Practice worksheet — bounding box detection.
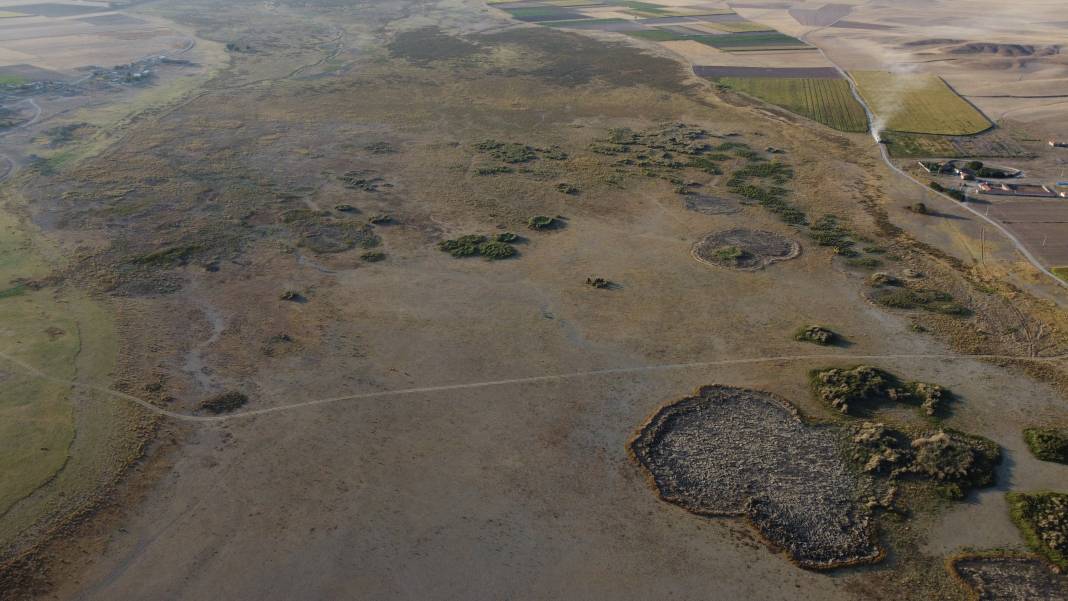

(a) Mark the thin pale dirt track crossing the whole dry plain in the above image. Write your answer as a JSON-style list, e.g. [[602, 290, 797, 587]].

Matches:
[[0, 353, 1068, 423]]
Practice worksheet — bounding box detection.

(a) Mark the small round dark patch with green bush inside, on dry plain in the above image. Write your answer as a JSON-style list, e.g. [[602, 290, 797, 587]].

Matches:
[[691, 228, 801, 271]]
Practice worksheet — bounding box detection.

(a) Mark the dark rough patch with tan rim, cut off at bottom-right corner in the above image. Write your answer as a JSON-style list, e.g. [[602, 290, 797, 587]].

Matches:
[[949, 555, 1068, 601]]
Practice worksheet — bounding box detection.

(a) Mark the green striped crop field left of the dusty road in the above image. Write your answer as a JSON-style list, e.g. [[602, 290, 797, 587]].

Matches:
[[717, 77, 867, 131]]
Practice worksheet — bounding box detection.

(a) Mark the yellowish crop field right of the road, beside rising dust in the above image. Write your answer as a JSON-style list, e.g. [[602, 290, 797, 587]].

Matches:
[[850, 70, 992, 136]]
